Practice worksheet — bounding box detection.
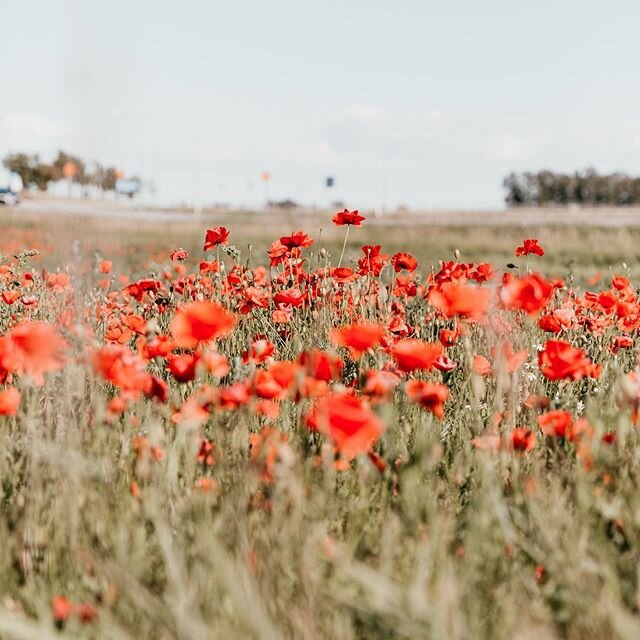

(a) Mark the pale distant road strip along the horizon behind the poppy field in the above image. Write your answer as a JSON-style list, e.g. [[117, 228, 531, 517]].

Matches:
[[6, 199, 640, 227]]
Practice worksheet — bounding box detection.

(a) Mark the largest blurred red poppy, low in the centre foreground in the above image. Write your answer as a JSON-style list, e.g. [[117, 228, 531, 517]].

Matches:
[[307, 393, 383, 460]]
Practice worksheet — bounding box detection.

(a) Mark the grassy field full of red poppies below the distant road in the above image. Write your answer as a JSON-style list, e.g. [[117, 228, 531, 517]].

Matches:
[[0, 210, 640, 640]]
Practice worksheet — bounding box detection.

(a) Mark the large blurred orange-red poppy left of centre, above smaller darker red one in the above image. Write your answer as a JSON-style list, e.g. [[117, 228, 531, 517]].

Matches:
[[171, 301, 235, 348]]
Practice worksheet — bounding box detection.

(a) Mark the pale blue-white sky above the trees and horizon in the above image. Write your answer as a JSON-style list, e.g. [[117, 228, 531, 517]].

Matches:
[[0, 0, 640, 209]]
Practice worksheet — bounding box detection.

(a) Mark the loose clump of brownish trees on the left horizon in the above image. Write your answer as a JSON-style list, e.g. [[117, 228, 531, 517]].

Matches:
[[2, 151, 131, 193]]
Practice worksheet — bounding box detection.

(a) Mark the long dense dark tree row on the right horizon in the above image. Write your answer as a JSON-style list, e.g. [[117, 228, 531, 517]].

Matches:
[[503, 169, 640, 207]]
